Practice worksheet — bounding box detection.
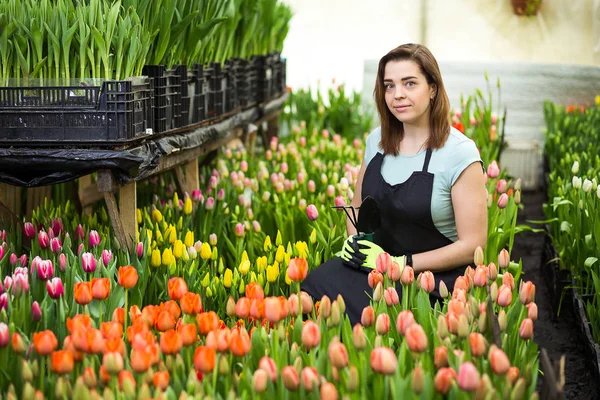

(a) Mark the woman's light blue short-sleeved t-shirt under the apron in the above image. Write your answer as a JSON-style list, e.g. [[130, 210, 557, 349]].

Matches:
[[364, 127, 483, 242]]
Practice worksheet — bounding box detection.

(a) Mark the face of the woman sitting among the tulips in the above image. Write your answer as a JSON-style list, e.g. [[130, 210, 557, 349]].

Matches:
[[383, 60, 435, 126]]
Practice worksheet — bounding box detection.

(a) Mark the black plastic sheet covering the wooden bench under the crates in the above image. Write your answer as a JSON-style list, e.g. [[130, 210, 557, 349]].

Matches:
[[0, 99, 278, 187]]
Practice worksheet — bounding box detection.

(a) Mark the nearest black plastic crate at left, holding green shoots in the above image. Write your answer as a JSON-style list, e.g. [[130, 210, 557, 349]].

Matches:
[[0, 78, 153, 144]]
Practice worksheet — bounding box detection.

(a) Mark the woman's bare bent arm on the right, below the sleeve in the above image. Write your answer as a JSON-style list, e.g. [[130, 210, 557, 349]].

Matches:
[[412, 163, 488, 272]]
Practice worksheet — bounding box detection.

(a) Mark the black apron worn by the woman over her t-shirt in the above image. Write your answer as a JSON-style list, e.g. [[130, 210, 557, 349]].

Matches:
[[301, 149, 466, 325]]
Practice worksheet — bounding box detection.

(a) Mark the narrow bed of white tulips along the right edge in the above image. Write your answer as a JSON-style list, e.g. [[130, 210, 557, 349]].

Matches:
[[544, 98, 600, 376]]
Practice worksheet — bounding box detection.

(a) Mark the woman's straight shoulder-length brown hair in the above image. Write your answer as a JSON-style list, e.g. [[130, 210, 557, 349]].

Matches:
[[373, 43, 450, 156]]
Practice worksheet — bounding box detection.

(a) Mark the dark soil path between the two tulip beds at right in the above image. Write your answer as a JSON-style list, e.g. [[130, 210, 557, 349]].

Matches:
[[511, 191, 600, 400]]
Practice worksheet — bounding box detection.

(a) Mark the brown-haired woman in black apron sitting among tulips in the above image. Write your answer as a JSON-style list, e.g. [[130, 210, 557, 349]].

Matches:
[[302, 44, 487, 325]]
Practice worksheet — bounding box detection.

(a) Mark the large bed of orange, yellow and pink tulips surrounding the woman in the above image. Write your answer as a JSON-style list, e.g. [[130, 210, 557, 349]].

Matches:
[[0, 91, 538, 399]]
